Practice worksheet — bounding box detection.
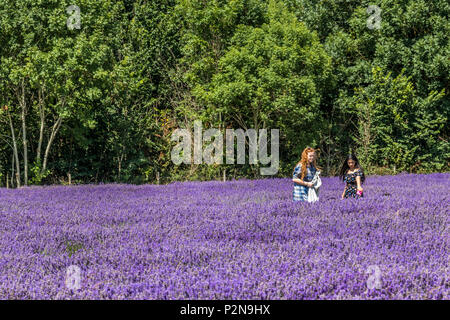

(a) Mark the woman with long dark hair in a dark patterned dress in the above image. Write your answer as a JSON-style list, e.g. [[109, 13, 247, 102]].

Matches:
[[340, 154, 365, 199]]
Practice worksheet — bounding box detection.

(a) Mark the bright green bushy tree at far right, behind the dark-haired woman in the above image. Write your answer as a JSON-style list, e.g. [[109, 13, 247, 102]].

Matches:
[[349, 68, 450, 172]]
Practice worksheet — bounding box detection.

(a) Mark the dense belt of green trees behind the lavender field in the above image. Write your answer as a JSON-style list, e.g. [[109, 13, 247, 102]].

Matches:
[[0, 0, 450, 186]]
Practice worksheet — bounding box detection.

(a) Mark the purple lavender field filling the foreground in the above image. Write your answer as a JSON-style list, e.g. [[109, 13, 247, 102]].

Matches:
[[0, 173, 450, 299]]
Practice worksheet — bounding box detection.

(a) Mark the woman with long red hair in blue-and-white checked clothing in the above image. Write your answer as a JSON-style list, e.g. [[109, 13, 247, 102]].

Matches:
[[292, 147, 320, 201]]
